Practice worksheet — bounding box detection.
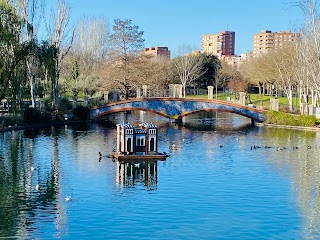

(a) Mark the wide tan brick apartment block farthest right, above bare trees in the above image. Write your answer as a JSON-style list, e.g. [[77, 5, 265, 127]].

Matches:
[[253, 30, 300, 57]]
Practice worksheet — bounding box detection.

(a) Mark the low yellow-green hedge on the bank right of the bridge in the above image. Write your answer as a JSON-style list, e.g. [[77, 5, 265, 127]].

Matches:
[[265, 111, 317, 127]]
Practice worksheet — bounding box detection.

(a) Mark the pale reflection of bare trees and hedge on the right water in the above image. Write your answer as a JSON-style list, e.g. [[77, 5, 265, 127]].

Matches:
[[260, 128, 320, 239]]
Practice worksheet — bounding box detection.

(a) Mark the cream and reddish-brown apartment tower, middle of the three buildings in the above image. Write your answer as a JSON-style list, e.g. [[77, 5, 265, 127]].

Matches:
[[201, 31, 235, 57]]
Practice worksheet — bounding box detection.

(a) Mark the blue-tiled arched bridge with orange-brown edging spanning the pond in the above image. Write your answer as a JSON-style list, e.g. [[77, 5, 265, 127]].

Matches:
[[90, 98, 265, 122]]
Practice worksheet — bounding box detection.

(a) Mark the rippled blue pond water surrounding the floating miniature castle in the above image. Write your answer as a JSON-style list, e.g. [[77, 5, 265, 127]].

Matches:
[[0, 113, 320, 239]]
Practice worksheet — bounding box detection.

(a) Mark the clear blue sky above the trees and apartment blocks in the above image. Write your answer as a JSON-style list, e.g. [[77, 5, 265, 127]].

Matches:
[[69, 0, 303, 56]]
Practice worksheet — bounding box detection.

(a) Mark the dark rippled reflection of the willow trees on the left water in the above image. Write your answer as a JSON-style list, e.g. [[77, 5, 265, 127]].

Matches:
[[0, 128, 63, 238]]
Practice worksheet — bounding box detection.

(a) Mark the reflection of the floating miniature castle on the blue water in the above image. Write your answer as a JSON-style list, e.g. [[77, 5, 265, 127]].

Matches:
[[117, 160, 158, 190]]
